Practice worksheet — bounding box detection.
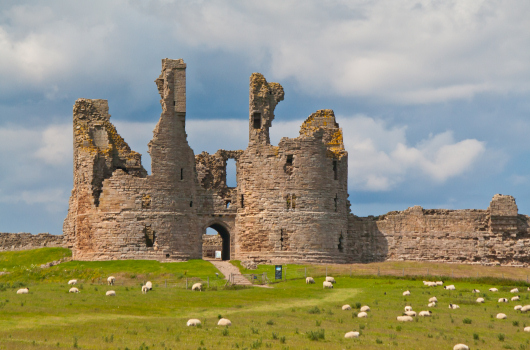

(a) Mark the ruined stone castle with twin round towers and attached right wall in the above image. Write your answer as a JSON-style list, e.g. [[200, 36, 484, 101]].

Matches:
[[63, 59, 530, 265]]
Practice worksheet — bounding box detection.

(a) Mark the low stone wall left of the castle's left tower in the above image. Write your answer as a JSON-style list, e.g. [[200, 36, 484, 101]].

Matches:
[[0, 232, 64, 251]]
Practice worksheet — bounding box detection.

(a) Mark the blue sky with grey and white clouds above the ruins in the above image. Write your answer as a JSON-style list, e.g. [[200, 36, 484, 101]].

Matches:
[[0, 0, 530, 234]]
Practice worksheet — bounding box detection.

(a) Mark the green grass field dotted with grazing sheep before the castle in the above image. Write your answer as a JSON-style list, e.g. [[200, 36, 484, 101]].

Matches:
[[0, 247, 530, 350]]
